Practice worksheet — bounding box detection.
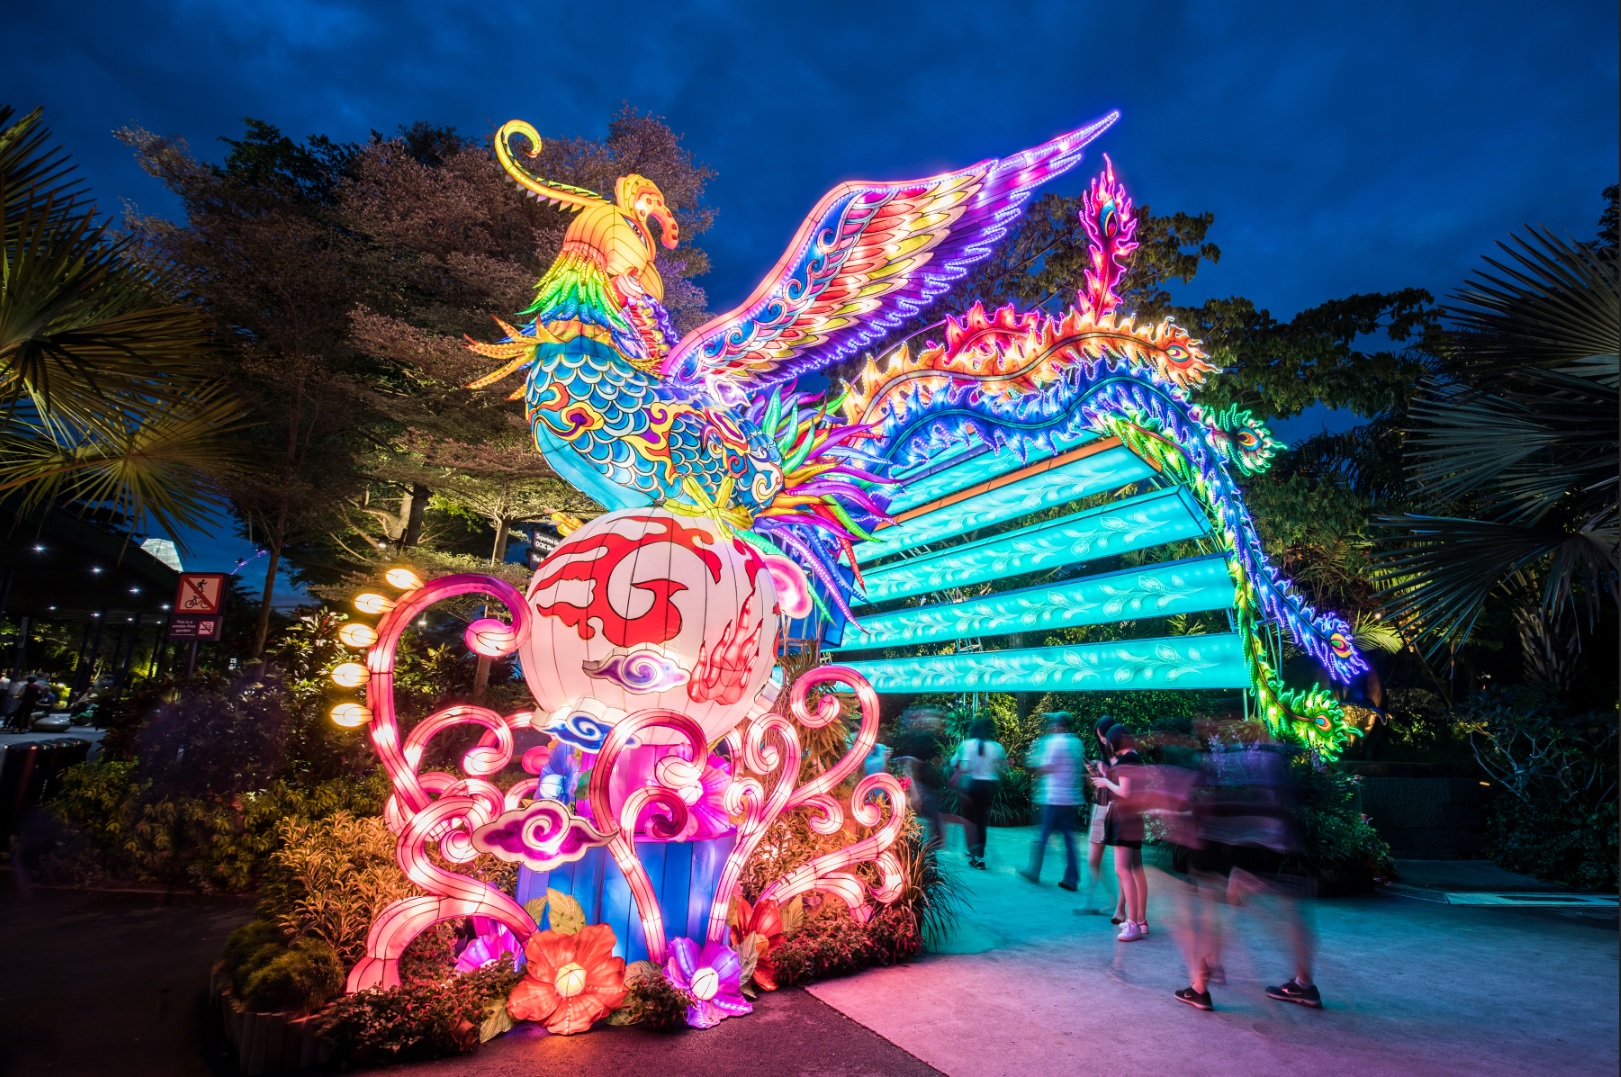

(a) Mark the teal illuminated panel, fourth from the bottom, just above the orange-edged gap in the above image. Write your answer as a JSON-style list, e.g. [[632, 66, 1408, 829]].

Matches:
[[856, 446, 1154, 564]]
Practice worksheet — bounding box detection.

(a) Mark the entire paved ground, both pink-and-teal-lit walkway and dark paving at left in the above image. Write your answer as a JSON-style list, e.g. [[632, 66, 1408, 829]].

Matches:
[[0, 830, 1618, 1077]]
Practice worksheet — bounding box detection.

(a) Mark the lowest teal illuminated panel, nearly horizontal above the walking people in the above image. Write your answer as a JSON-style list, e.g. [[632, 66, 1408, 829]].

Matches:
[[845, 633, 1250, 693]]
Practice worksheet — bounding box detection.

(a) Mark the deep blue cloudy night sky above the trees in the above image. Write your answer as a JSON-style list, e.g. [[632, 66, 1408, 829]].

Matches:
[[0, 0, 1621, 583]]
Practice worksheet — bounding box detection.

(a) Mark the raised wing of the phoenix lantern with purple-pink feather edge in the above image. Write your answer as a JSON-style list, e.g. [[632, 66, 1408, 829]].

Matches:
[[661, 112, 1120, 388]]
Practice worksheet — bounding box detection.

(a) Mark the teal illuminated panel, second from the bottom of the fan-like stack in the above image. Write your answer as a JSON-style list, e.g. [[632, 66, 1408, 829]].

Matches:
[[830, 553, 1234, 650]]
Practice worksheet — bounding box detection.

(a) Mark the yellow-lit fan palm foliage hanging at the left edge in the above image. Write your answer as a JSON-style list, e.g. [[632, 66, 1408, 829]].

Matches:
[[0, 107, 242, 548]]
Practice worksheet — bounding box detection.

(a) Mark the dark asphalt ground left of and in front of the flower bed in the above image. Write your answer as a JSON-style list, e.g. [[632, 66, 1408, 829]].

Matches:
[[0, 873, 935, 1077]]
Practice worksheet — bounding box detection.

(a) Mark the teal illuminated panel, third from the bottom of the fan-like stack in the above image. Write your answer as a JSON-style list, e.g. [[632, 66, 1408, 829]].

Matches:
[[862, 488, 1208, 605]]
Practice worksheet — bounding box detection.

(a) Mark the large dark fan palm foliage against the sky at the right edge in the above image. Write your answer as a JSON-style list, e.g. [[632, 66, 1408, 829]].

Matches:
[[1375, 220, 1621, 654]]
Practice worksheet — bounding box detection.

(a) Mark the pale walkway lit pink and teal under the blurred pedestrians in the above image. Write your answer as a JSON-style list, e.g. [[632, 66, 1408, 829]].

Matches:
[[811, 830, 1618, 1077]]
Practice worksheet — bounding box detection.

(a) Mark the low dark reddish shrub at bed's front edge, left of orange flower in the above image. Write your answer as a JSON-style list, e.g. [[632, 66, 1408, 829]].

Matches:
[[321, 957, 522, 1062]]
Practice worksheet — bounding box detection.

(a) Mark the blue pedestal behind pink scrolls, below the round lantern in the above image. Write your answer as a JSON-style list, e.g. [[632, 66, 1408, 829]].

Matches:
[[517, 834, 738, 962]]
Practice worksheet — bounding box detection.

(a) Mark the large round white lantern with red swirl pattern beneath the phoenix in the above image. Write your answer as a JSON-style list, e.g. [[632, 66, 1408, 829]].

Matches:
[[524, 508, 780, 741]]
